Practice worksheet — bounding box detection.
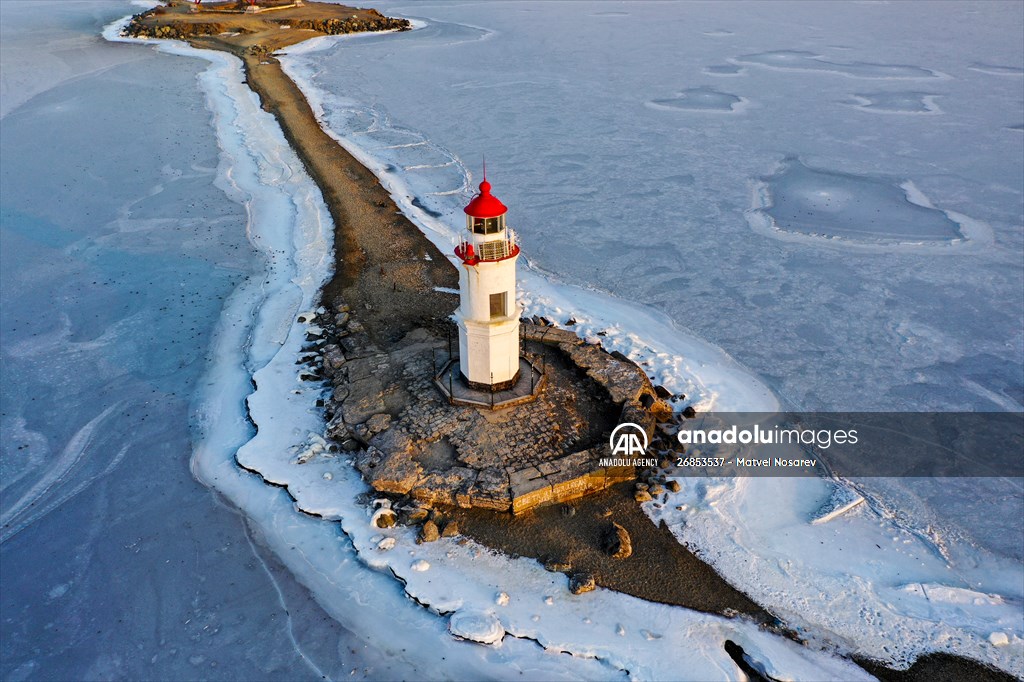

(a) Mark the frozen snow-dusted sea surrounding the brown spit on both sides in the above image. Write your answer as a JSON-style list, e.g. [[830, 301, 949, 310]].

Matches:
[[0, 2, 1024, 679]]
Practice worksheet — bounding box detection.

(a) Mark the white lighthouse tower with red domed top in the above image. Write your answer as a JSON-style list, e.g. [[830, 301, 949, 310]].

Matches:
[[455, 171, 522, 392]]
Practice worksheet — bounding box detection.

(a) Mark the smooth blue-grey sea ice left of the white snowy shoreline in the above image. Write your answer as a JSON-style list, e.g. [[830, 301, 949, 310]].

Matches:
[[0, 0, 411, 682]]
